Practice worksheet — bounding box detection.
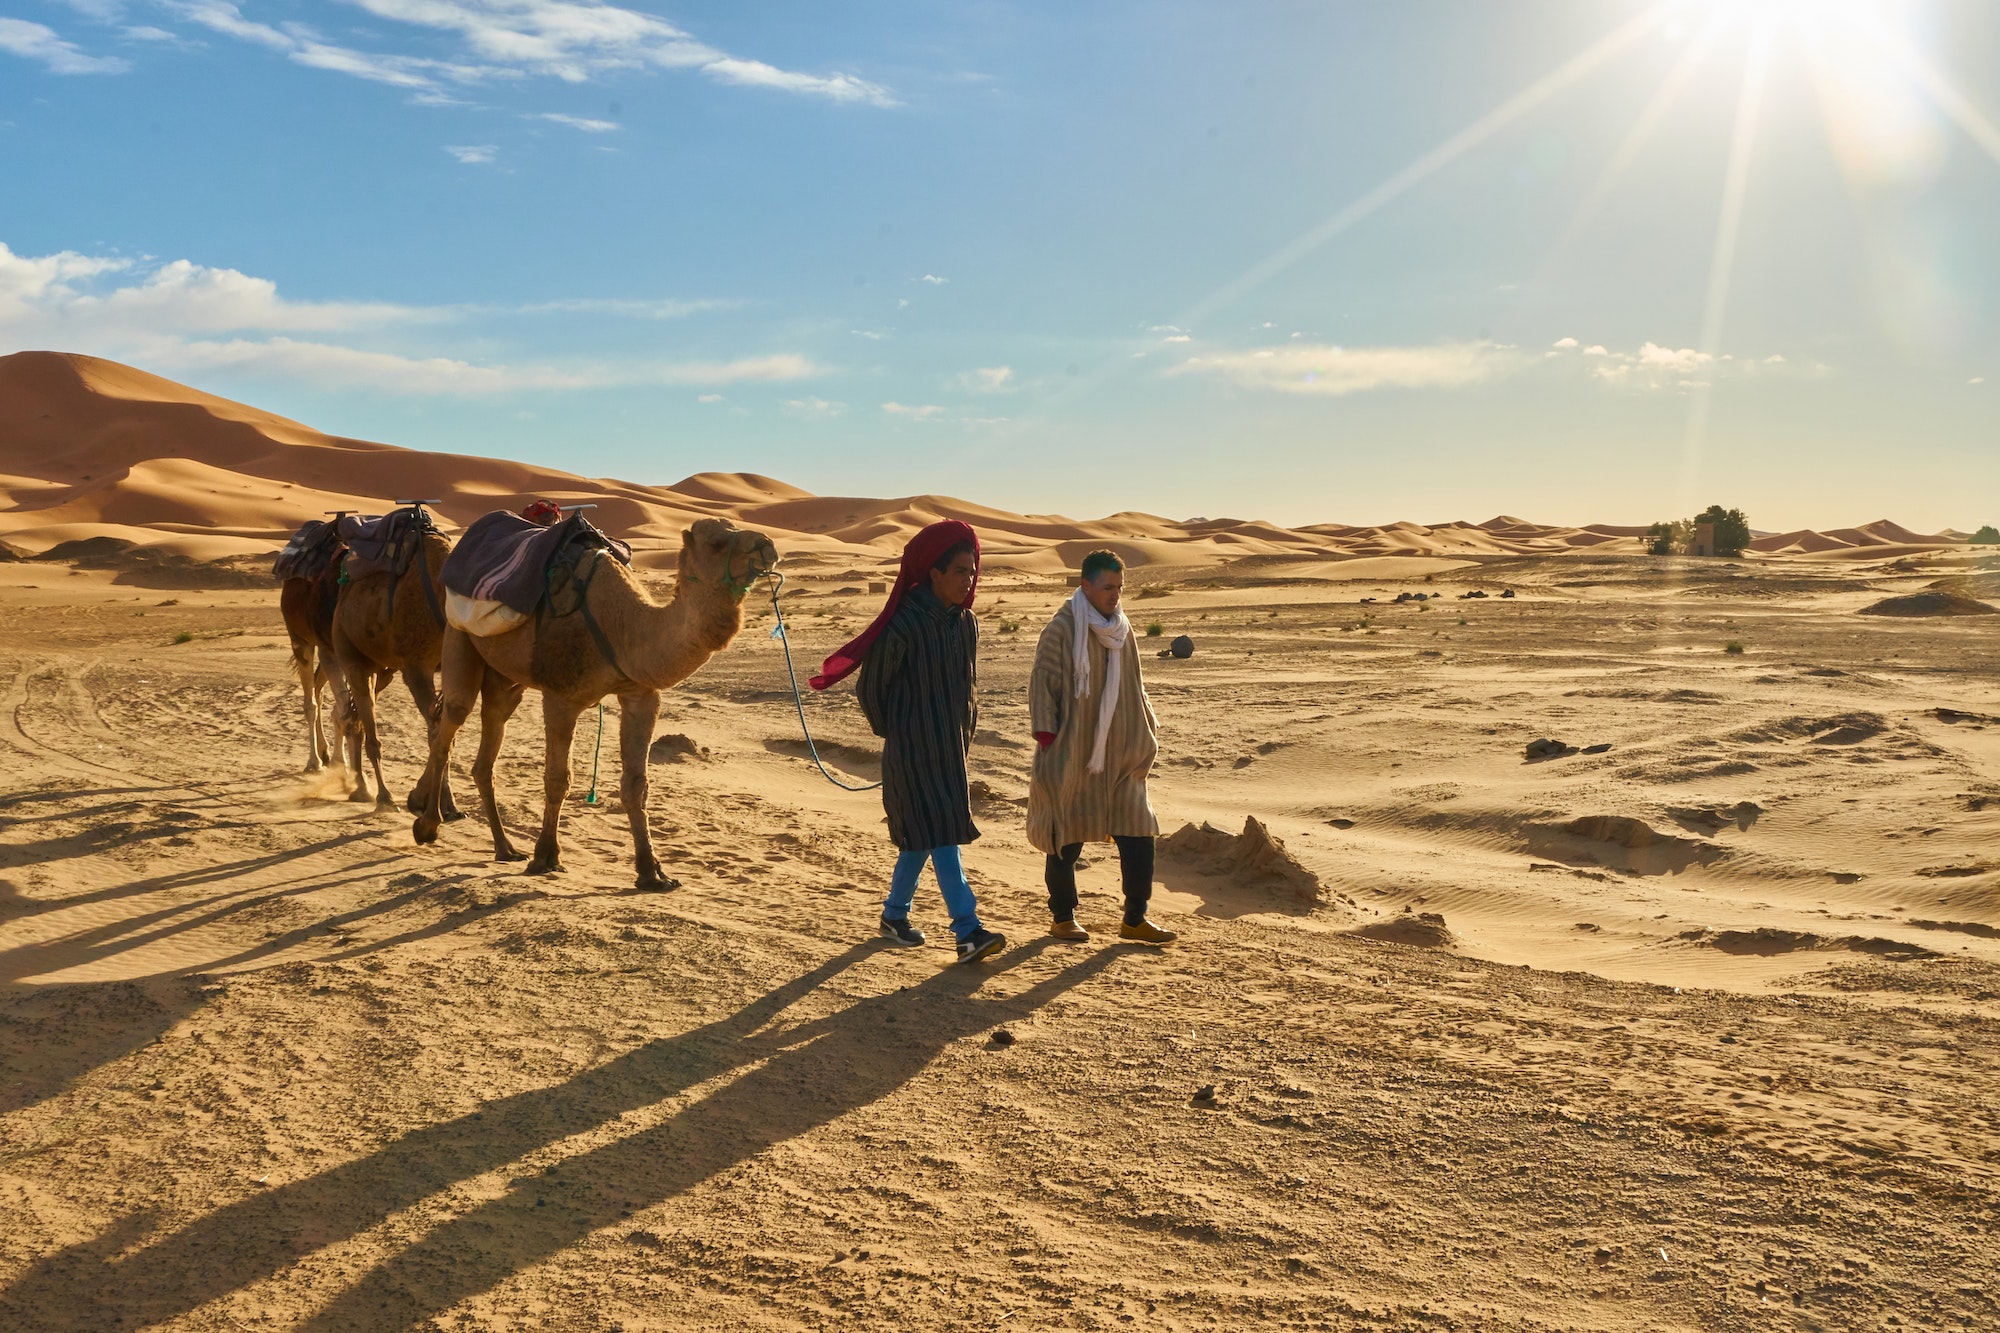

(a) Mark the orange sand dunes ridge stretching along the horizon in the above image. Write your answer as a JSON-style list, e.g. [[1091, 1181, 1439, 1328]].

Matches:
[[0, 352, 1964, 572]]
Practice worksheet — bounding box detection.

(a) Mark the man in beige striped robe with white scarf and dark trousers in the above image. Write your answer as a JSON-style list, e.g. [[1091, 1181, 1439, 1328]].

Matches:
[[1028, 550, 1174, 945]]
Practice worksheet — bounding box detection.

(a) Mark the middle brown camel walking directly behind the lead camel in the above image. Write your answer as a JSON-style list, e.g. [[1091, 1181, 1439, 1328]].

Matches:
[[332, 504, 460, 819]]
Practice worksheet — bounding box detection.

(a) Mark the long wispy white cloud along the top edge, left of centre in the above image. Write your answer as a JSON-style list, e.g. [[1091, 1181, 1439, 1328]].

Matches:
[[162, 0, 896, 106]]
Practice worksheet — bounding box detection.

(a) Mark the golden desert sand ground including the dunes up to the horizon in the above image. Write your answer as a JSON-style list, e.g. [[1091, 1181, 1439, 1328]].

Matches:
[[0, 352, 2000, 1331]]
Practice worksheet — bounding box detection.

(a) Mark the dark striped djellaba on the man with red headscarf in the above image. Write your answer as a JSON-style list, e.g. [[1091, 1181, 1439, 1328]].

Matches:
[[854, 584, 980, 851]]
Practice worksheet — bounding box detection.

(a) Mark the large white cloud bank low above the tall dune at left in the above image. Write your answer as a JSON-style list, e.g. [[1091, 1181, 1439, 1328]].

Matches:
[[0, 244, 824, 394]]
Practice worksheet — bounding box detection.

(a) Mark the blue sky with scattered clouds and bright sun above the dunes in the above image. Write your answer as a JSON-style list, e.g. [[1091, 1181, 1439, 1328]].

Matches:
[[0, 0, 2000, 528]]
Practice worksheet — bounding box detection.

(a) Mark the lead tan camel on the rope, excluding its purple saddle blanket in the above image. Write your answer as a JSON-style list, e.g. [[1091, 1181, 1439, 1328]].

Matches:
[[412, 518, 778, 889]]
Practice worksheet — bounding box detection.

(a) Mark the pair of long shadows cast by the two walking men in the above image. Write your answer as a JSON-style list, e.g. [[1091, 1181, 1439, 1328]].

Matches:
[[0, 932, 1122, 1329]]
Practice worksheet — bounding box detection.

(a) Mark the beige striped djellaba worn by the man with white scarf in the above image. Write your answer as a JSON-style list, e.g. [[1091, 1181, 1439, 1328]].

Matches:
[[1028, 602, 1160, 855]]
